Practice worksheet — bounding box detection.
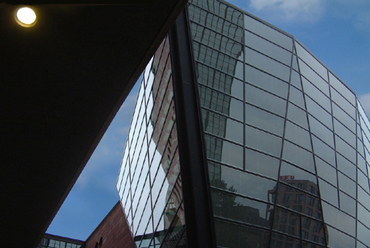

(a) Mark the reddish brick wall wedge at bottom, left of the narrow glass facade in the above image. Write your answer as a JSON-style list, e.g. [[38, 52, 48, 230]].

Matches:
[[86, 202, 136, 248]]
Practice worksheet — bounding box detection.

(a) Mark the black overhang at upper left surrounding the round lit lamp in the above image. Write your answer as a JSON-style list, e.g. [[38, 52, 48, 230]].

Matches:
[[0, 0, 187, 247]]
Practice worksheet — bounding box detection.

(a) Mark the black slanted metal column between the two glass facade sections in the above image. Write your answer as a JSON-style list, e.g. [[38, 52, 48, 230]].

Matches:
[[169, 9, 216, 247]]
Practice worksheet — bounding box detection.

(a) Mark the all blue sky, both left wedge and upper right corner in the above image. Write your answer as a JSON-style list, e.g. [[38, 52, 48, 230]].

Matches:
[[47, 0, 370, 240]]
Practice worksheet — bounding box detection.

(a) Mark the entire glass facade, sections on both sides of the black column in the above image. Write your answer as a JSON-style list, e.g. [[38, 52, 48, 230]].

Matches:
[[117, 0, 370, 248]]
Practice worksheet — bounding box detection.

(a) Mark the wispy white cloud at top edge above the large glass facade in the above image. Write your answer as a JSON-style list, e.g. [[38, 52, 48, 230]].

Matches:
[[250, 0, 324, 22]]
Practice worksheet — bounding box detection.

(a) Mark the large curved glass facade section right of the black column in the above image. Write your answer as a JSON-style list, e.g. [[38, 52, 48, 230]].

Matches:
[[188, 0, 370, 248]]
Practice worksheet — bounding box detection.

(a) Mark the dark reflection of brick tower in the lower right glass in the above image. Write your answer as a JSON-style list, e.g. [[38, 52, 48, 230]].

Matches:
[[266, 175, 325, 247]]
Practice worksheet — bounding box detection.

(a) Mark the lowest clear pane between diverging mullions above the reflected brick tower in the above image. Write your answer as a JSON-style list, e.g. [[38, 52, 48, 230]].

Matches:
[[283, 141, 315, 172]]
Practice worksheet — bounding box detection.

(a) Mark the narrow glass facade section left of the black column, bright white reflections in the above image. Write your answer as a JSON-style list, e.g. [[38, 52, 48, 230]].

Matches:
[[117, 38, 186, 247]]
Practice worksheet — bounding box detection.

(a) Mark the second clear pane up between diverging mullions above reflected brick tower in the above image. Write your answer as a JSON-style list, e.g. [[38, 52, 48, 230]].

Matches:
[[284, 121, 311, 150]]
